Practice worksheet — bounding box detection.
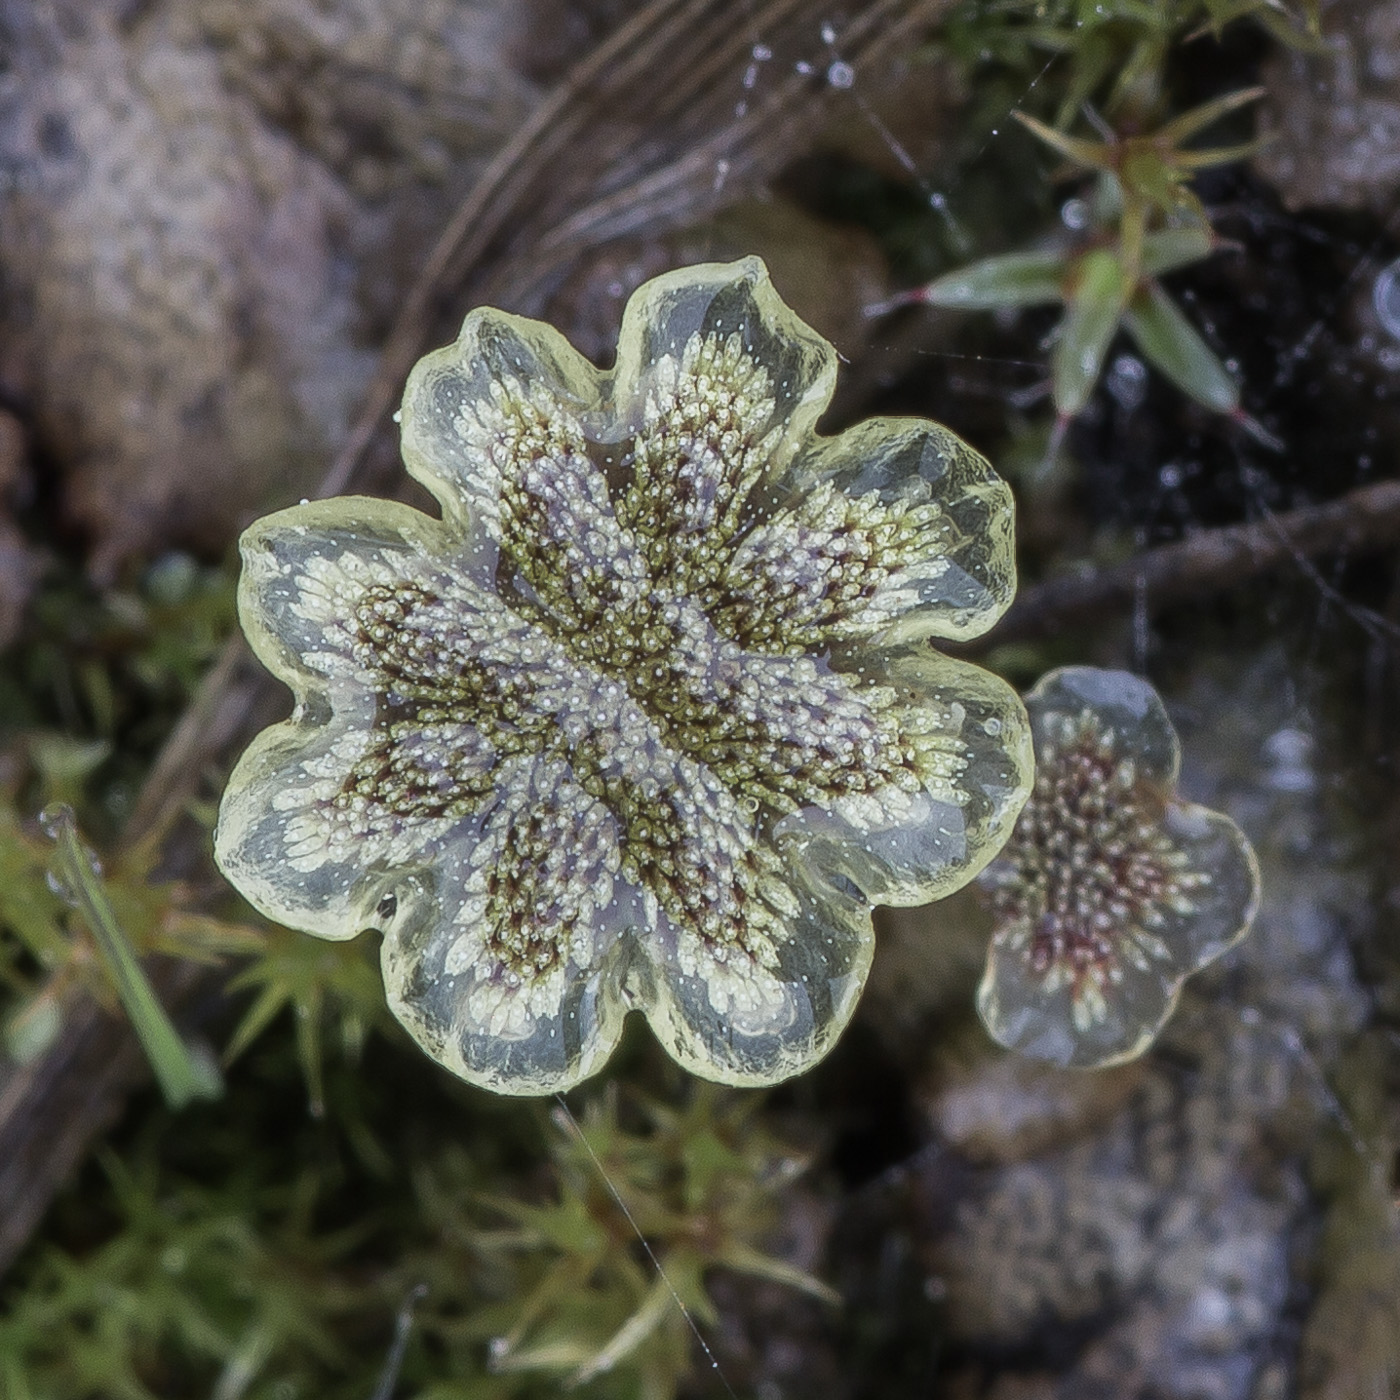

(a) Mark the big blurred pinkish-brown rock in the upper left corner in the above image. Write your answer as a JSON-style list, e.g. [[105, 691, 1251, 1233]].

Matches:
[[0, 0, 531, 573]]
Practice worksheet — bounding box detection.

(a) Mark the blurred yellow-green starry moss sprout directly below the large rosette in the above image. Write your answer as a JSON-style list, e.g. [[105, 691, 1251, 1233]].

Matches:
[[476, 1084, 840, 1400]]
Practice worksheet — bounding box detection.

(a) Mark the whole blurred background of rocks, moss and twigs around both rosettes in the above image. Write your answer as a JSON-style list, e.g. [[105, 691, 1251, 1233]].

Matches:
[[0, 0, 1400, 1400]]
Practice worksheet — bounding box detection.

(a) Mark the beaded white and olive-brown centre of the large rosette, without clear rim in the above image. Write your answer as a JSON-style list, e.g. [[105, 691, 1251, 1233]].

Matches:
[[280, 333, 963, 1035]]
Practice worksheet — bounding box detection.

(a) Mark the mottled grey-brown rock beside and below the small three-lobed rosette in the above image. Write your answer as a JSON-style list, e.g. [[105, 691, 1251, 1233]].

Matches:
[[846, 648, 1397, 1400]]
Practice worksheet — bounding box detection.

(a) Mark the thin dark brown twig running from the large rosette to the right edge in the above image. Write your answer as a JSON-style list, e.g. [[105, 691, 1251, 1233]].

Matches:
[[986, 482, 1400, 645]]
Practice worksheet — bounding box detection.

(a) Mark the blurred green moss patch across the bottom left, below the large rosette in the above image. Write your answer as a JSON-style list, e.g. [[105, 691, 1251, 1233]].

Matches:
[[0, 1029, 830, 1400]]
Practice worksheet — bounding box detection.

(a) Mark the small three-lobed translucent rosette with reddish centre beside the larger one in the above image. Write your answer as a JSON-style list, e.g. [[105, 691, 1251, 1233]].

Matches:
[[977, 666, 1259, 1068]]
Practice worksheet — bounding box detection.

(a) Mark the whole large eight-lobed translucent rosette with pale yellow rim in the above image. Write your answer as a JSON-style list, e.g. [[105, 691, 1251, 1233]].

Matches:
[[216, 258, 1030, 1093]]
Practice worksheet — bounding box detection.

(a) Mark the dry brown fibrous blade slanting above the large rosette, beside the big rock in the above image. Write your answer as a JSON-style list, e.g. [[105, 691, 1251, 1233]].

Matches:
[[321, 0, 948, 496]]
